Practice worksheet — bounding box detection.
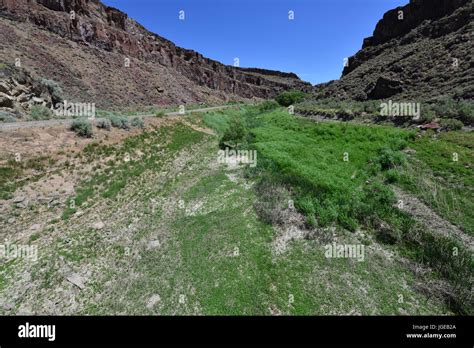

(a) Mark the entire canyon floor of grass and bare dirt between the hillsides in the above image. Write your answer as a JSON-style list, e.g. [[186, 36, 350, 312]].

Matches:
[[0, 106, 473, 315]]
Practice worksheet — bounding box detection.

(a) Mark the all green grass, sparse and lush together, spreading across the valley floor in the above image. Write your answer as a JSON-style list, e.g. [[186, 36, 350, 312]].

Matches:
[[0, 107, 472, 315]]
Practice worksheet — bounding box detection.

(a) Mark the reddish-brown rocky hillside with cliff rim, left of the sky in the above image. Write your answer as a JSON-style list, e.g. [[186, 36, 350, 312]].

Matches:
[[0, 0, 311, 112]]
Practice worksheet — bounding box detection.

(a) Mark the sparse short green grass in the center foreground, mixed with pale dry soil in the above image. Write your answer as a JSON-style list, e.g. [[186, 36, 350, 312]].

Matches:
[[79, 130, 446, 315]]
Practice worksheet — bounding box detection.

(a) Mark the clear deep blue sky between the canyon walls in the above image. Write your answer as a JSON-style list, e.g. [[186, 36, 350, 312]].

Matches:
[[103, 0, 408, 84]]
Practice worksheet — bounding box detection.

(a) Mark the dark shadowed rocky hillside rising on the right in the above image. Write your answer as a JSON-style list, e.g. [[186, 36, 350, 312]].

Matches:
[[316, 0, 474, 100]]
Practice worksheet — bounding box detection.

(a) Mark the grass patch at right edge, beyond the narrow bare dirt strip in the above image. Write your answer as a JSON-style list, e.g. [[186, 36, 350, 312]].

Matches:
[[398, 132, 474, 236]]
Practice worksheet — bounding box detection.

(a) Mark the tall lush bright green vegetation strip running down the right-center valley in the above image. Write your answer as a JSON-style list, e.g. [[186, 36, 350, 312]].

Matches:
[[204, 104, 473, 313]]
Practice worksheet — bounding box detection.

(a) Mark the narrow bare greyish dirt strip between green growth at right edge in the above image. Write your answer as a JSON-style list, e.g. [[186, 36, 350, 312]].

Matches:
[[393, 186, 474, 250]]
